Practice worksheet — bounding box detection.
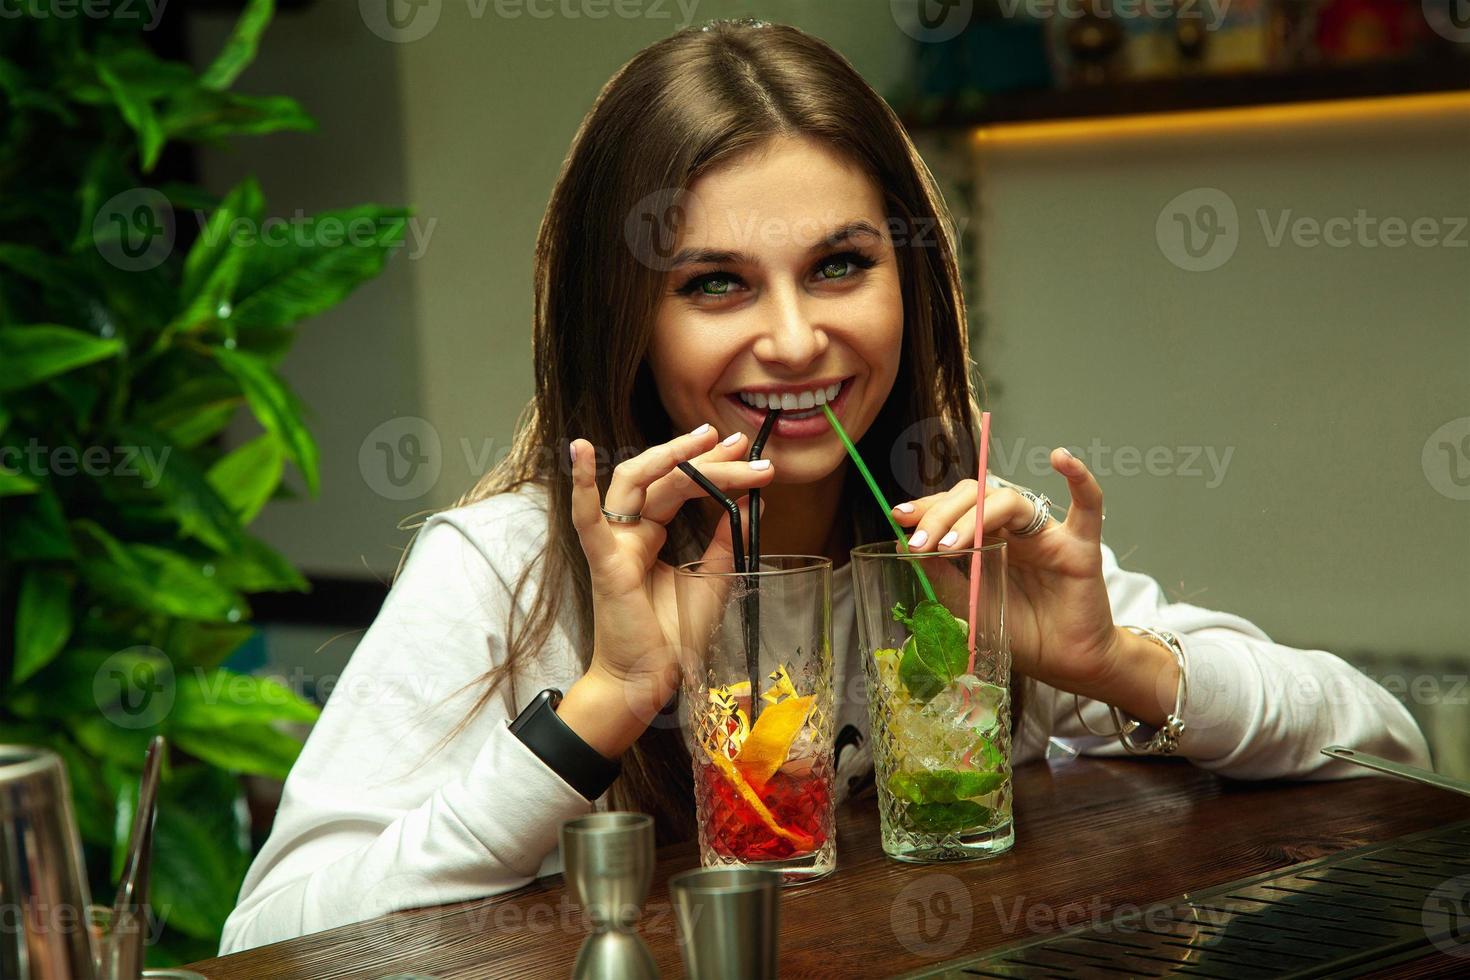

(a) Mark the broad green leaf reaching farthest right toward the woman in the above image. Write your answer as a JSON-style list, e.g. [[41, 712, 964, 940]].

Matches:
[[232, 206, 409, 332]]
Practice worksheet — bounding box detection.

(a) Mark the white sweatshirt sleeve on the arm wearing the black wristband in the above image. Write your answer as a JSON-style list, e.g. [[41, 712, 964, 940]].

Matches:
[[219, 514, 592, 955]]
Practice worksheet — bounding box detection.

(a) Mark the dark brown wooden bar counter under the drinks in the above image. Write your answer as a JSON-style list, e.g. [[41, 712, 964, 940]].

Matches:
[[190, 758, 1470, 980]]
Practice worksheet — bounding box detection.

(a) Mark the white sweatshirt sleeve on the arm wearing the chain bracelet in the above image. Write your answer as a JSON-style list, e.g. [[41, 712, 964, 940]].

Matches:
[[1053, 545, 1429, 779]]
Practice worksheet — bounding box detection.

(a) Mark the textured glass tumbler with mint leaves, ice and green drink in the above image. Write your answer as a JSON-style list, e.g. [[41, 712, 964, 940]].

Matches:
[[851, 541, 1016, 862]]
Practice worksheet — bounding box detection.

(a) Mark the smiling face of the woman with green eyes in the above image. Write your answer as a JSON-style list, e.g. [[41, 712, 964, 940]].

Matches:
[[648, 138, 904, 483]]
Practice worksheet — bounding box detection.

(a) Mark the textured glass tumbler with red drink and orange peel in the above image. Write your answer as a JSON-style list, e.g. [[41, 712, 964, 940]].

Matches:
[[675, 555, 836, 884]]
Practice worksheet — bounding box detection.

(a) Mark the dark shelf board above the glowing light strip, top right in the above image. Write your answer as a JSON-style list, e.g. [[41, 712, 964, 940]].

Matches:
[[903, 59, 1470, 129]]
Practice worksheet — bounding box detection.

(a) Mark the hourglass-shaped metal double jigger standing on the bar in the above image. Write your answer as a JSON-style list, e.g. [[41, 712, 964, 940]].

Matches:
[[562, 813, 659, 980]]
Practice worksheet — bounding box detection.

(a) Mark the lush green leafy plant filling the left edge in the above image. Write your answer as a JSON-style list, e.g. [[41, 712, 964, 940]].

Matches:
[[0, 0, 407, 965]]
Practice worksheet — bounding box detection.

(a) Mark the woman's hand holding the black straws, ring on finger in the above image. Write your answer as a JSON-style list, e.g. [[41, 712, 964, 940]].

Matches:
[[557, 426, 775, 758]]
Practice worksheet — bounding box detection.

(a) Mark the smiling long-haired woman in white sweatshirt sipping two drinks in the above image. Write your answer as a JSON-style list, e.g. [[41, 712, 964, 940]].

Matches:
[[222, 22, 1427, 952]]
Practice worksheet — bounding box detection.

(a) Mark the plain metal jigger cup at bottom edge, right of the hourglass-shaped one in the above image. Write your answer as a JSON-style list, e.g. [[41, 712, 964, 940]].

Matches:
[[669, 868, 781, 980]]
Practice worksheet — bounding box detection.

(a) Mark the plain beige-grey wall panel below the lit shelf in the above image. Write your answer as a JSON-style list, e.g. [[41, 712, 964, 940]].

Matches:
[[976, 100, 1470, 658]]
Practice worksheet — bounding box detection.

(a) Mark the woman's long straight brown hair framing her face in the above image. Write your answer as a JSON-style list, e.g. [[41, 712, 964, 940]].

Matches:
[[414, 21, 978, 840]]
